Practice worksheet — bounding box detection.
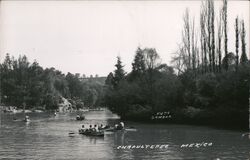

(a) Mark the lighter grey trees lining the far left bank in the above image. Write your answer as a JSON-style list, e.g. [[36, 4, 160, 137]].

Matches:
[[0, 54, 103, 110]]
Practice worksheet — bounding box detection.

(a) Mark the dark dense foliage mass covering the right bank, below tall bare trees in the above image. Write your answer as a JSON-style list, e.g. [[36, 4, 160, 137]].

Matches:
[[104, 44, 250, 128]]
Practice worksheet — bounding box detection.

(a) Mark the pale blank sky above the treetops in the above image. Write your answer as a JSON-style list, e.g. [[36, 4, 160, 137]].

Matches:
[[0, 0, 250, 76]]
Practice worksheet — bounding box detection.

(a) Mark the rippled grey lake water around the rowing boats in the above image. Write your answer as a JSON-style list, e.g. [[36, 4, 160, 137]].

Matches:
[[0, 110, 250, 160]]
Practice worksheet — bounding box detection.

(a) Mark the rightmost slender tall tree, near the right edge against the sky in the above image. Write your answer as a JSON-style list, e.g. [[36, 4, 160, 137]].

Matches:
[[240, 20, 248, 64]]
